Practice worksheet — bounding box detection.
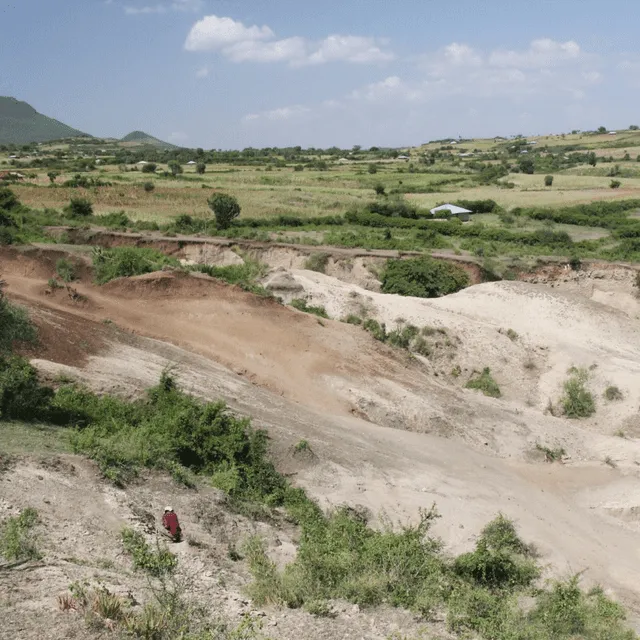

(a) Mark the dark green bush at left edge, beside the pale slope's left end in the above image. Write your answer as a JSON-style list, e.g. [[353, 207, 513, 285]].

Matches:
[[0, 356, 53, 421]]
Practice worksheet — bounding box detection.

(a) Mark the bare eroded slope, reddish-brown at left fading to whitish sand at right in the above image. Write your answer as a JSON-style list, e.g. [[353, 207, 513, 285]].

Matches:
[[0, 252, 640, 620]]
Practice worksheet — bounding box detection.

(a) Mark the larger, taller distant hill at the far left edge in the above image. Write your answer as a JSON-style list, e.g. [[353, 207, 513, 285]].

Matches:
[[0, 96, 91, 144]]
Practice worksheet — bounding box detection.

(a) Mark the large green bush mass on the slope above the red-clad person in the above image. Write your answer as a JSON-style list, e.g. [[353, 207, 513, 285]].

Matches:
[[54, 373, 287, 504]]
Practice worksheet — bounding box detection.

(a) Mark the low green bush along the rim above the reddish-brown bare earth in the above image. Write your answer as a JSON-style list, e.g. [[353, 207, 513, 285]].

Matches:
[[93, 247, 180, 284]]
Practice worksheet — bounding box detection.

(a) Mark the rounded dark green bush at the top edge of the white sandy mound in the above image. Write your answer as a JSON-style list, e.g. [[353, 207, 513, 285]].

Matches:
[[382, 257, 469, 298]]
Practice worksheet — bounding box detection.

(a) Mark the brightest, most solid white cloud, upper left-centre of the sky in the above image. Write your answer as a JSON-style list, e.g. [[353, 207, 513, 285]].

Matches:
[[184, 15, 394, 66]]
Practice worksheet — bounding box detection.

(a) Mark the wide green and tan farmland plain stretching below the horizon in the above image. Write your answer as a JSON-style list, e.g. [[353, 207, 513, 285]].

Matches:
[[0, 130, 640, 268]]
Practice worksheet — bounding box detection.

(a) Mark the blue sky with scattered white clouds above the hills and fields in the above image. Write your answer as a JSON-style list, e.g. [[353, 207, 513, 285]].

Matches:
[[0, 0, 640, 149]]
